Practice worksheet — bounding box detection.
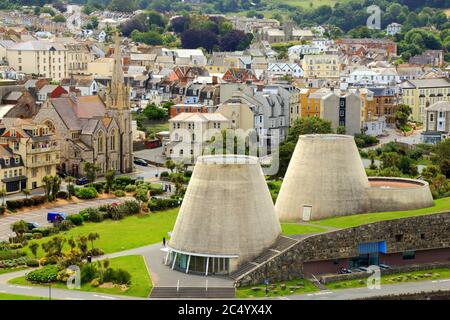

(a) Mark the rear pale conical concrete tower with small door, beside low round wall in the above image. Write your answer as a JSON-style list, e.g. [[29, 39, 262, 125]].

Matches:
[[275, 134, 370, 222]]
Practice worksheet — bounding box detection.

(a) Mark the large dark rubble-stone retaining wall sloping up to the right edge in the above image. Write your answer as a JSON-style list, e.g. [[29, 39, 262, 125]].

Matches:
[[236, 212, 450, 286]]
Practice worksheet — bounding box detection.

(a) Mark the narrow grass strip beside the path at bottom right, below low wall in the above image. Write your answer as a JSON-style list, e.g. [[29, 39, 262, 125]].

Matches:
[[325, 268, 450, 289]]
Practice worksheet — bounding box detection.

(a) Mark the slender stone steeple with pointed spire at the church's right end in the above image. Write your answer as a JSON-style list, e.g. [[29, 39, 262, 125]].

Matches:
[[105, 33, 133, 173]]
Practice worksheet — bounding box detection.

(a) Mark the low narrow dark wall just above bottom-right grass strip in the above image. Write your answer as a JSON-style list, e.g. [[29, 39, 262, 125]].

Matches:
[[318, 262, 450, 283]]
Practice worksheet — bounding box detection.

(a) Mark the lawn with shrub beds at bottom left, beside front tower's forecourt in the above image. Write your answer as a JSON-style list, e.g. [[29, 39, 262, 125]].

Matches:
[[9, 255, 152, 298]]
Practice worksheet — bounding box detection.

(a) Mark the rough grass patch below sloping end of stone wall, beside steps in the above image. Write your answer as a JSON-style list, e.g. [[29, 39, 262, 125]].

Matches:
[[236, 279, 319, 299]]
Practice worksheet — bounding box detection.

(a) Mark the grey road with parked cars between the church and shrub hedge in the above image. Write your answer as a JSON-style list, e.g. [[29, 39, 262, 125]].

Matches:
[[0, 198, 118, 240]]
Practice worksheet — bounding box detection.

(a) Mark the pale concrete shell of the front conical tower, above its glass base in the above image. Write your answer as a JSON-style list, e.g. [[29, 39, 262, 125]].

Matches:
[[169, 155, 281, 263]]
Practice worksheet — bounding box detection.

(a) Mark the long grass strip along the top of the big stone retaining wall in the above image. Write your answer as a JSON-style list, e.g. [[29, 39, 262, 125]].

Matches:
[[311, 197, 450, 228]]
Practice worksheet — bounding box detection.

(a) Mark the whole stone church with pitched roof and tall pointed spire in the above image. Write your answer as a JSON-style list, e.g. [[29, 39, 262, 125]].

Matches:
[[33, 34, 133, 177]]
